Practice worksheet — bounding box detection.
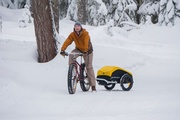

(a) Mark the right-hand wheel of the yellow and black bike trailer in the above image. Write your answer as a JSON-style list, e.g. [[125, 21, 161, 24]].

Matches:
[[120, 73, 133, 91]]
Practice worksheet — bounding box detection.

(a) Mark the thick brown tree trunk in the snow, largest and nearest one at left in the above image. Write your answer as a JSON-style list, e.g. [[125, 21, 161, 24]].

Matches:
[[31, 0, 56, 63]]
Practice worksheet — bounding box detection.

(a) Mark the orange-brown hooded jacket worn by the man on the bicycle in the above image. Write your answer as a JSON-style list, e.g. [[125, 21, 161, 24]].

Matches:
[[61, 29, 93, 53]]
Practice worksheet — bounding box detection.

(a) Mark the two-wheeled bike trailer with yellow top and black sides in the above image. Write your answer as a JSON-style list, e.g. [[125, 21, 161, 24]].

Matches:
[[96, 66, 133, 91]]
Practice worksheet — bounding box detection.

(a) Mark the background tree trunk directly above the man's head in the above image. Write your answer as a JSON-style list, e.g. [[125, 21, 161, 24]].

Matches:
[[77, 0, 87, 24]]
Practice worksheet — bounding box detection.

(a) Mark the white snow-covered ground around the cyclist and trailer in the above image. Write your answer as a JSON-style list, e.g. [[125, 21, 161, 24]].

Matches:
[[0, 7, 180, 120]]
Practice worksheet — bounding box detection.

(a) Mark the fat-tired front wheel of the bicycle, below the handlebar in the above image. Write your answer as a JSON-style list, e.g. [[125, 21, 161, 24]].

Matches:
[[67, 64, 78, 94]]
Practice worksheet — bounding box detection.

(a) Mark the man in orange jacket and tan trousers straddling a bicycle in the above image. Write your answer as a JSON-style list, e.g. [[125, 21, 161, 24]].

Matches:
[[60, 22, 96, 91]]
